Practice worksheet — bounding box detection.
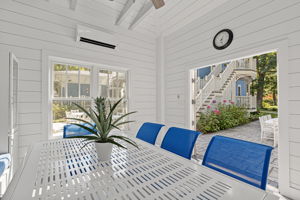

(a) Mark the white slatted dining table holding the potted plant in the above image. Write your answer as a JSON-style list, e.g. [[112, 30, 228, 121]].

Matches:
[[4, 139, 278, 200]]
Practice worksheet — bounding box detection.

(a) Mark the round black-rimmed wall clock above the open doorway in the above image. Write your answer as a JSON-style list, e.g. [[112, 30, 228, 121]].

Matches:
[[213, 29, 233, 50]]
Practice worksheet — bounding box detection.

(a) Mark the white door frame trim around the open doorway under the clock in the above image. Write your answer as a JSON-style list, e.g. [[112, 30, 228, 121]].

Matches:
[[186, 38, 292, 197]]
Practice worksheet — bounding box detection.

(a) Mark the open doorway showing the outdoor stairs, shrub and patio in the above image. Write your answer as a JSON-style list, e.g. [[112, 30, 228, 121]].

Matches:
[[190, 51, 278, 188]]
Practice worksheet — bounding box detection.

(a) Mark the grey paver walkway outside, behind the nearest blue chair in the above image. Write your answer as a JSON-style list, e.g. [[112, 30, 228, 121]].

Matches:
[[193, 121, 278, 188]]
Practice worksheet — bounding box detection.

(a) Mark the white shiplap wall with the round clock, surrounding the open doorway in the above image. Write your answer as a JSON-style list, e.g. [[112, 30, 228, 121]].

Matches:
[[164, 0, 300, 199]]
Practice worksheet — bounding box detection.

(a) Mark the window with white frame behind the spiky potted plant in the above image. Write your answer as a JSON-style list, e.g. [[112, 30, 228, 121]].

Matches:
[[51, 62, 128, 137]]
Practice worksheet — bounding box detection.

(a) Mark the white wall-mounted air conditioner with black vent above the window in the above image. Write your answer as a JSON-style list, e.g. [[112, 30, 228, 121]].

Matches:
[[76, 25, 117, 49]]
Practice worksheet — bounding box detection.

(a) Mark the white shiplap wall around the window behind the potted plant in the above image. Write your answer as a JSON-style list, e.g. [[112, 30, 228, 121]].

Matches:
[[0, 0, 156, 164]]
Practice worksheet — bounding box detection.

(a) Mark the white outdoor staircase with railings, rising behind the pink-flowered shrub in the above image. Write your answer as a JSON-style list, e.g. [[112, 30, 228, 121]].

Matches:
[[193, 59, 256, 113]]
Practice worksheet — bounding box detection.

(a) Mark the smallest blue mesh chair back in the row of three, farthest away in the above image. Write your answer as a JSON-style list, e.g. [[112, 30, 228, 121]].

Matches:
[[136, 122, 165, 145]]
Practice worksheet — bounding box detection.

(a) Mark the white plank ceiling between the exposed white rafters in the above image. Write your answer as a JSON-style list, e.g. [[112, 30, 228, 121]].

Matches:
[[47, 0, 228, 35]]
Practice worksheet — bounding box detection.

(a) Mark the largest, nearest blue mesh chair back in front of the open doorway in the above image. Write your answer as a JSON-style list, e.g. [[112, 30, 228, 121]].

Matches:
[[202, 136, 273, 190]]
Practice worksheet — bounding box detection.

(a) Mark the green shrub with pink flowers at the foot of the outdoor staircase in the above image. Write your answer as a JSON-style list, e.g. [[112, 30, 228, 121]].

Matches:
[[197, 104, 250, 133]]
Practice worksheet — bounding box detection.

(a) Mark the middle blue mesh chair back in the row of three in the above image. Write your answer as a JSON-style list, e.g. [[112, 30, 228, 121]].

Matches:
[[161, 127, 201, 159]]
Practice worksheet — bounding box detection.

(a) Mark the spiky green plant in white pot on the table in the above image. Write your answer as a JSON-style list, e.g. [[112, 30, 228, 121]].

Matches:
[[69, 97, 138, 161]]
